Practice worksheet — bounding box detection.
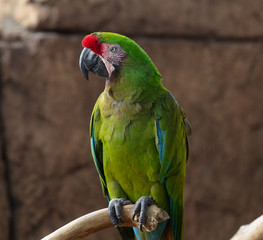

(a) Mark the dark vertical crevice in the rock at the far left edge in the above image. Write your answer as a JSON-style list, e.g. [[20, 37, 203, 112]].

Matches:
[[0, 49, 15, 240]]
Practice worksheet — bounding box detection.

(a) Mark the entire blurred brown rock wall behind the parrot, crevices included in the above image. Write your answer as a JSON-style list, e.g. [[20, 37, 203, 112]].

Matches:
[[0, 0, 263, 240]]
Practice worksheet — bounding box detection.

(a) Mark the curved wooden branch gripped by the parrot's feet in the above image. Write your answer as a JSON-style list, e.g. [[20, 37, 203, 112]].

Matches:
[[42, 204, 169, 240]]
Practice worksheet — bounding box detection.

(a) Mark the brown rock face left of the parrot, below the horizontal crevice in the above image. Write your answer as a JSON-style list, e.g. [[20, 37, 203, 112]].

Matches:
[[1, 30, 117, 240]]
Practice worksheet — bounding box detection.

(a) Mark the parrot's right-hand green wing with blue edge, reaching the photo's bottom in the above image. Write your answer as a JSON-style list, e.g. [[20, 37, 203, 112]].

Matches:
[[155, 93, 191, 240]]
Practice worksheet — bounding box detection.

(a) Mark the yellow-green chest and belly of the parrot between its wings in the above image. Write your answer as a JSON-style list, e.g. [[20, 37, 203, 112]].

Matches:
[[100, 94, 160, 200]]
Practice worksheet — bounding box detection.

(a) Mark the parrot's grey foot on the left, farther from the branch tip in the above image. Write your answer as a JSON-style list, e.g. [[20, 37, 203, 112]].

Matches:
[[108, 198, 132, 228]]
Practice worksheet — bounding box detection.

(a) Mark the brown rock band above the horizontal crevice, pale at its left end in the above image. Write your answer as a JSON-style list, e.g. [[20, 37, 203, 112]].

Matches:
[[0, 0, 263, 38]]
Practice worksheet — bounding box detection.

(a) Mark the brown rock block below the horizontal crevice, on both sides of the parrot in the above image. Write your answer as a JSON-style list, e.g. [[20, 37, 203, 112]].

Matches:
[[1, 30, 263, 240]]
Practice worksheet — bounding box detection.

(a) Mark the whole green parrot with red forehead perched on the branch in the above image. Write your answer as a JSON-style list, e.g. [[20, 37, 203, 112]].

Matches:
[[79, 32, 191, 240]]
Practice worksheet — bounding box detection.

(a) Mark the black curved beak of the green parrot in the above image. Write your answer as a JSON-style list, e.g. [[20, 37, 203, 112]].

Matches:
[[79, 48, 109, 80]]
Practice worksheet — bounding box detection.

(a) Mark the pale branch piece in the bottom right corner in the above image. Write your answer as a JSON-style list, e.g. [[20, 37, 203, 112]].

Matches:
[[230, 215, 263, 240]]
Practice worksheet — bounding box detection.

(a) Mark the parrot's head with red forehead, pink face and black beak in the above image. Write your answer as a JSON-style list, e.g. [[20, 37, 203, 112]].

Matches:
[[79, 32, 161, 82]]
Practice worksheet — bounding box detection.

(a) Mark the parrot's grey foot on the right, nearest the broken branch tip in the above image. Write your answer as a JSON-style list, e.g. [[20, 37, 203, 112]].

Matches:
[[132, 196, 156, 232]]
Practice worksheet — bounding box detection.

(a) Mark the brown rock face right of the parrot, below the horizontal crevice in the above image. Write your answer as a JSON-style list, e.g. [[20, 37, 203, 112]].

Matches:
[[142, 40, 263, 240]]
